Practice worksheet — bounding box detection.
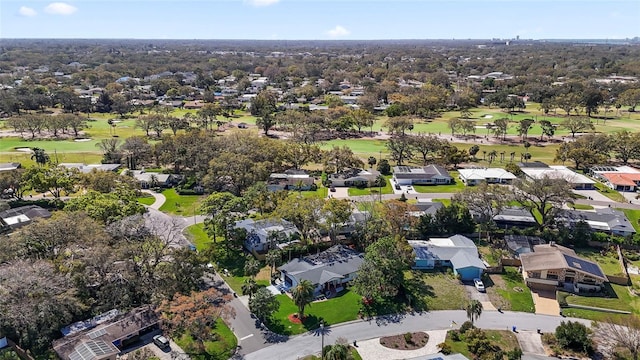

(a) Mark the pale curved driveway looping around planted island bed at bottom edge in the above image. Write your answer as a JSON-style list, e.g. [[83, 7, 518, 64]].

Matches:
[[357, 330, 447, 360]]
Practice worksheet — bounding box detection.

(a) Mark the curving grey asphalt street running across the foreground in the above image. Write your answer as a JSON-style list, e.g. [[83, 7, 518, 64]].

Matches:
[[244, 310, 591, 360]]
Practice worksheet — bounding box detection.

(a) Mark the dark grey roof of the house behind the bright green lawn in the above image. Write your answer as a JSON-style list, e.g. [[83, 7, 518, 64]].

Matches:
[[278, 245, 364, 285]]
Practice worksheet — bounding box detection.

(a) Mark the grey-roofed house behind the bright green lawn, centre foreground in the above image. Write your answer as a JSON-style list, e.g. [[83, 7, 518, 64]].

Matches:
[[278, 245, 364, 295]]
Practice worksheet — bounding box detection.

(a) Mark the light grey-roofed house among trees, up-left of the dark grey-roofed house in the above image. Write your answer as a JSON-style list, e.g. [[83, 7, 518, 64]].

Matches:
[[234, 219, 301, 255]]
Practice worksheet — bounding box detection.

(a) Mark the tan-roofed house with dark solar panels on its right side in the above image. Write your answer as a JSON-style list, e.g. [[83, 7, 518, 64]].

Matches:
[[520, 243, 609, 293]]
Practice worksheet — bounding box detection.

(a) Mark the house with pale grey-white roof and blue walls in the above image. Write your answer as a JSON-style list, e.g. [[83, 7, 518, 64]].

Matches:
[[409, 235, 486, 280]]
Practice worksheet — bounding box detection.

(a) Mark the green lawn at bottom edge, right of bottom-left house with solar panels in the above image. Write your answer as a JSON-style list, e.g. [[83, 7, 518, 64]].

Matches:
[[173, 319, 238, 360]]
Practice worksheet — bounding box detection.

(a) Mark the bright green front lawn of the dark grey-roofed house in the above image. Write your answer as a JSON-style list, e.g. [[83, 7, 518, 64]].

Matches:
[[269, 290, 361, 335]]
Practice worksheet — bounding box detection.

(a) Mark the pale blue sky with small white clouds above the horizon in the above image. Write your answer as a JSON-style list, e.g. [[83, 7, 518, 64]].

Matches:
[[0, 0, 640, 40]]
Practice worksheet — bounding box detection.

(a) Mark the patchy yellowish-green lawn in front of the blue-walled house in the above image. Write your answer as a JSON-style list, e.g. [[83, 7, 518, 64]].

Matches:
[[405, 270, 469, 311]]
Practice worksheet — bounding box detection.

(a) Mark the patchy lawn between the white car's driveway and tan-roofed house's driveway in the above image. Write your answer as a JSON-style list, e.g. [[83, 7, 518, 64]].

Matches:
[[485, 267, 535, 312]]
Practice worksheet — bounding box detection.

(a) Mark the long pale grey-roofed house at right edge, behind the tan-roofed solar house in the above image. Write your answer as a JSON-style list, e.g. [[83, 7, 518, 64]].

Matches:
[[556, 208, 636, 236]]
